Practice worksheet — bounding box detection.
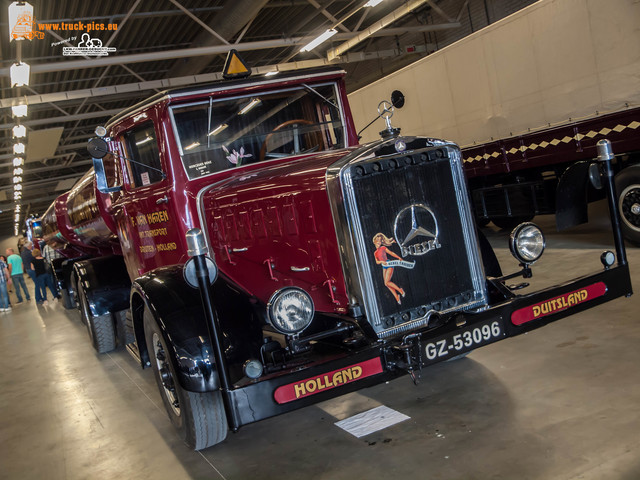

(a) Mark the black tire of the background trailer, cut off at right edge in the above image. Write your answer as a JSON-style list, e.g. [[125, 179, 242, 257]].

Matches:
[[615, 167, 640, 246]]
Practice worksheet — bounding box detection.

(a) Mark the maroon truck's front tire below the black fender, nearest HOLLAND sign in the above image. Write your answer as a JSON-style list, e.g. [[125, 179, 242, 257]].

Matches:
[[144, 307, 228, 450]]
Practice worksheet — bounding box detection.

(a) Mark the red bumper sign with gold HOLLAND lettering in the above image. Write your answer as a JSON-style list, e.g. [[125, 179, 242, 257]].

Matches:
[[273, 358, 382, 404]]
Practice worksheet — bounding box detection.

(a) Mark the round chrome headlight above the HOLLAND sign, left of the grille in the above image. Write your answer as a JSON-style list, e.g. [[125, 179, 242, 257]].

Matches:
[[267, 287, 314, 335]]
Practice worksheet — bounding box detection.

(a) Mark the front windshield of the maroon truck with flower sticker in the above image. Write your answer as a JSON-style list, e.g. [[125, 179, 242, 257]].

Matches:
[[172, 84, 345, 179]]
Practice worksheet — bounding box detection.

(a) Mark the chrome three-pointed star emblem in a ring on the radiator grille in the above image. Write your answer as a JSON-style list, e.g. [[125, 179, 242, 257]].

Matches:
[[393, 203, 442, 257]]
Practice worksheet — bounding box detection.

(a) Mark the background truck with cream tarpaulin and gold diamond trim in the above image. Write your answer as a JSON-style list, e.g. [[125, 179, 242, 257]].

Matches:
[[349, 0, 640, 245]]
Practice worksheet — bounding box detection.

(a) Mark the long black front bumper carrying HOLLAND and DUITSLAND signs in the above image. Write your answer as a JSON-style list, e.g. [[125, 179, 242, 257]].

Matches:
[[229, 264, 632, 427]]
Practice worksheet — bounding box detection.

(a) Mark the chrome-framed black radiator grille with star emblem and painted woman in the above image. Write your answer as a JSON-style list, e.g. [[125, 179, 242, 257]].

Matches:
[[341, 144, 486, 338]]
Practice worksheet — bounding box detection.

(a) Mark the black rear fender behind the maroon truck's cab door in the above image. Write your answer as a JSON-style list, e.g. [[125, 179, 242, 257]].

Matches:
[[73, 255, 131, 316]]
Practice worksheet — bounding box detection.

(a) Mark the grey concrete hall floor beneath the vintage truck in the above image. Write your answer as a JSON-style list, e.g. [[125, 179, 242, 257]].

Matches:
[[0, 204, 640, 480]]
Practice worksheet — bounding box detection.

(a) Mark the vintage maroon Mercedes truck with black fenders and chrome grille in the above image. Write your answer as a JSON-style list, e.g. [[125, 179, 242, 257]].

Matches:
[[42, 63, 632, 449]]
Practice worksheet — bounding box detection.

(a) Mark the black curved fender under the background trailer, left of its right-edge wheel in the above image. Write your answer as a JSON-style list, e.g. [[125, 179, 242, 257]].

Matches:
[[556, 160, 592, 231]]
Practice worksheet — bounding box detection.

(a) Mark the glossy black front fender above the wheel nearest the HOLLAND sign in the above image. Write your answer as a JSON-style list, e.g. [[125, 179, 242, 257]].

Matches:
[[130, 265, 262, 392]]
